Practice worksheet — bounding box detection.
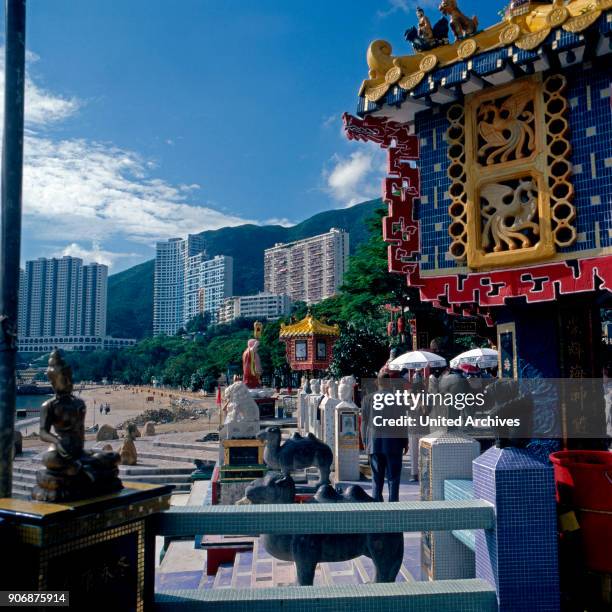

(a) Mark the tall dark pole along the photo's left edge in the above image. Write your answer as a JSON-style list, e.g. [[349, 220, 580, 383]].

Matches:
[[0, 0, 25, 497]]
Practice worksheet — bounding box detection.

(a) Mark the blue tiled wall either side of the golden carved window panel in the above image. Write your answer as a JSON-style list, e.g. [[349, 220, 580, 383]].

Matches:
[[415, 64, 612, 270]]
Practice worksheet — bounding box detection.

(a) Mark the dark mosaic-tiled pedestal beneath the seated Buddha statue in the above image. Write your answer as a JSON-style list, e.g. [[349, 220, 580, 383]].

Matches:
[[0, 483, 172, 612]]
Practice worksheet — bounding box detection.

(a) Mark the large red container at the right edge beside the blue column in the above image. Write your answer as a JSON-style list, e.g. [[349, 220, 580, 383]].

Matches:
[[550, 451, 612, 573]]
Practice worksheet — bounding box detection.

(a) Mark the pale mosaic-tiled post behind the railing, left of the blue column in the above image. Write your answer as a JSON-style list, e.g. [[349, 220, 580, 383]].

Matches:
[[419, 432, 480, 580]]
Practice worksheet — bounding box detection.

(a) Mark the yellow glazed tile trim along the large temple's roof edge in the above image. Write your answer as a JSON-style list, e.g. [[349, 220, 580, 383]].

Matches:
[[359, 0, 612, 102]]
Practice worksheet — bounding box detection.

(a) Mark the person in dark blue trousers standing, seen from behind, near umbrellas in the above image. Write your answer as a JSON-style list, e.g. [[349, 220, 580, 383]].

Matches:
[[361, 374, 408, 502]]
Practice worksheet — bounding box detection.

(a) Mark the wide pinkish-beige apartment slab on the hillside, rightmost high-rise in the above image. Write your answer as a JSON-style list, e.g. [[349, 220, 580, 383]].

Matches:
[[264, 228, 349, 304]]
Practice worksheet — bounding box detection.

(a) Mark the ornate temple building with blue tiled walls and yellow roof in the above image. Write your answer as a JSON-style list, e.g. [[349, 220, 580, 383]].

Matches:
[[344, 0, 612, 437]]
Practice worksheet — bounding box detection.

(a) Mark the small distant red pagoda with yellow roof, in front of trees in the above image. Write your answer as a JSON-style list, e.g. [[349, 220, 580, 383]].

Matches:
[[279, 313, 340, 374]]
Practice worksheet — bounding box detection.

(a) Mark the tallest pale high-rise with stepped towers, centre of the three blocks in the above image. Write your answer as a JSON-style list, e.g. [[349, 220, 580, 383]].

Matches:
[[153, 235, 234, 335]]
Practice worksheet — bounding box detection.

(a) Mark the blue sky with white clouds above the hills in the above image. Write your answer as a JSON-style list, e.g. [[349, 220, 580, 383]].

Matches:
[[3, 0, 501, 273]]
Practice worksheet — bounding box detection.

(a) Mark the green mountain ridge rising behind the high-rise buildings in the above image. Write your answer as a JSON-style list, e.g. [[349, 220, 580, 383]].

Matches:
[[107, 200, 381, 338]]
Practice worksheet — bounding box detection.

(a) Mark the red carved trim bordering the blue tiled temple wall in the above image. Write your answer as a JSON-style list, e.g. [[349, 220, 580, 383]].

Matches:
[[343, 113, 612, 308]]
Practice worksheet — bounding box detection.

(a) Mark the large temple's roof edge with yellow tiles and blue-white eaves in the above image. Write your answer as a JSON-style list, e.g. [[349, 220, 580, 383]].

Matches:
[[358, 0, 612, 120]]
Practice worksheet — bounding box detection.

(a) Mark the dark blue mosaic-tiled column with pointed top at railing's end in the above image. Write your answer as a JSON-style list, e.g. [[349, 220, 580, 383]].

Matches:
[[473, 447, 560, 612]]
